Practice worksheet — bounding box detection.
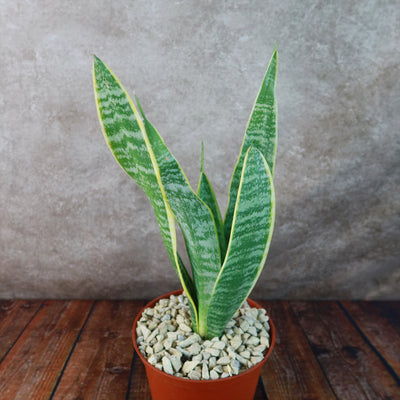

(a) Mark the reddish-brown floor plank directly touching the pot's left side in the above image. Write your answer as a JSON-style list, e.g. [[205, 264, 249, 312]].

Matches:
[[53, 301, 144, 400]]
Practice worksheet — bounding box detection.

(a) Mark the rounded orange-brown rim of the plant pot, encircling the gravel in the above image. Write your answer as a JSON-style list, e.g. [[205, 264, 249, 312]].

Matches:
[[132, 289, 276, 385]]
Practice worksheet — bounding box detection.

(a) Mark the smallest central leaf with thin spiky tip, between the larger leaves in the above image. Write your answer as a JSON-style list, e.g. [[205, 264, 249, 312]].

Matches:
[[197, 143, 226, 261]]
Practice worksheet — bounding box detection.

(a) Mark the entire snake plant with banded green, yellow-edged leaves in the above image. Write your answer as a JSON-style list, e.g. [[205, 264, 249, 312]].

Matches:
[[93, 49, 278, 338]]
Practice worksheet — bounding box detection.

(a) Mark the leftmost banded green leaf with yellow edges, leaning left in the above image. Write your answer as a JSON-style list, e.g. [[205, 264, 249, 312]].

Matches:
[[93, 57, 198, 329]]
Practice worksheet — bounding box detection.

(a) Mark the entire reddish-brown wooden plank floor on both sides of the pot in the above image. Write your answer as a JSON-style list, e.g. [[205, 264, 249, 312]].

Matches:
[[0, 300, 400, 400]]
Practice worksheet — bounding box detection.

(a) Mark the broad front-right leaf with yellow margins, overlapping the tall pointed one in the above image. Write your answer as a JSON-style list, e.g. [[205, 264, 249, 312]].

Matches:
[[207, 147, 275, 338]]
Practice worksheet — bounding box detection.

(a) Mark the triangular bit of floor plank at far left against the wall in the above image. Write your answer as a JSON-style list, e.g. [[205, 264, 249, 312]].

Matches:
[[0, 300, 43, 362]]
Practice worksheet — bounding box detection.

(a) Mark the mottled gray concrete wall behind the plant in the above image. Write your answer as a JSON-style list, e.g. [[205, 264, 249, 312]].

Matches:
[[0, 0, 400, 299]]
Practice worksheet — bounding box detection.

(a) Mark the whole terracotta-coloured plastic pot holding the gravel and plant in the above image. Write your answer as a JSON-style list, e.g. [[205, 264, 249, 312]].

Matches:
[[132, 290, 275, 400]]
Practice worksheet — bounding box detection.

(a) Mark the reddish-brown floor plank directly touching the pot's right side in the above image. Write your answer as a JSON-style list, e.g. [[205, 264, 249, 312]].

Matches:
[[259, 301, 336, 400]]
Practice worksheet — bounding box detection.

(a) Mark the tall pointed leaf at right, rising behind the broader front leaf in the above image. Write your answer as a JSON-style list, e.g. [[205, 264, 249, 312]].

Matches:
[[224, 49, 278, 241]]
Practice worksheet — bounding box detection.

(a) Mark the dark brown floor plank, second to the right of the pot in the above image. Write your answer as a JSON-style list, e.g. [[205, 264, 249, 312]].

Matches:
[[291, 302, 400, 400]]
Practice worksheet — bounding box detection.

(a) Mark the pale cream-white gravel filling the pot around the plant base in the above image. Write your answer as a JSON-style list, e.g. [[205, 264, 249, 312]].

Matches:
[[136, 294, 270, 380]]
